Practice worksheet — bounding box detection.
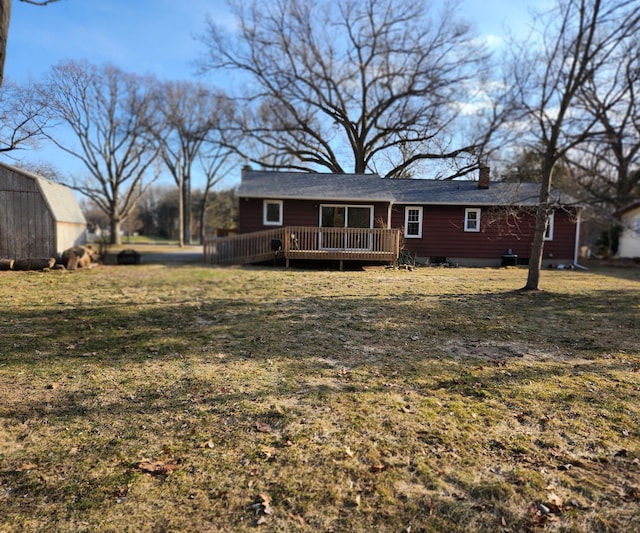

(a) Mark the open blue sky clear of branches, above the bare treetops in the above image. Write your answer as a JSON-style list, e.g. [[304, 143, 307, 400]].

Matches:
[[5, 0, 549, 187]]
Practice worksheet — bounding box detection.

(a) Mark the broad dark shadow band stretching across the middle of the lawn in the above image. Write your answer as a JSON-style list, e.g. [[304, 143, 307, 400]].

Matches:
[[0, 282, 640, 371]]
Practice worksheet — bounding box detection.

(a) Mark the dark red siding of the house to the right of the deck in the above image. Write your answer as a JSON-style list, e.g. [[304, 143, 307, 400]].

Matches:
[[391, 205, 576, 262]]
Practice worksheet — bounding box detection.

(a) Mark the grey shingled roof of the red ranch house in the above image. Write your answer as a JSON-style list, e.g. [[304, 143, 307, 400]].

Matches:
[[238, 169, 574, 206]]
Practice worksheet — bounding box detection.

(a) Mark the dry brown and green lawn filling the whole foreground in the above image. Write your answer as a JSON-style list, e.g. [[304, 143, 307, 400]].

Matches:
[[0, 265, 640, 532]]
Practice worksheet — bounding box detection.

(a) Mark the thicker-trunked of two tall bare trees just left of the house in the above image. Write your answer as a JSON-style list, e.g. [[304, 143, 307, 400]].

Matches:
[[153, 81, 232, 246]]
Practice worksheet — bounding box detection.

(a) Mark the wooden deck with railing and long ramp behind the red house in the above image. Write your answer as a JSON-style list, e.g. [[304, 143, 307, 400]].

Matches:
[[204, 226, 401, 268]]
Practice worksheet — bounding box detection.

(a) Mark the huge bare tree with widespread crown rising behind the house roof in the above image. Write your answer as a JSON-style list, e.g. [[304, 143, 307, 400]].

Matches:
[[203, 0, 496, 177]]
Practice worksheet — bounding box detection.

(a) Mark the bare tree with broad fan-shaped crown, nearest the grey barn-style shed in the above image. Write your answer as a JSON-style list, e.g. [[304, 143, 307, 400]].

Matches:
[[40, 62, 159, 244]]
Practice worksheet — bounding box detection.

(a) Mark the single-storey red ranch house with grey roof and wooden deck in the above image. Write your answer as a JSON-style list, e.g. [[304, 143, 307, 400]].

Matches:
[[206, 167, 579, 266]]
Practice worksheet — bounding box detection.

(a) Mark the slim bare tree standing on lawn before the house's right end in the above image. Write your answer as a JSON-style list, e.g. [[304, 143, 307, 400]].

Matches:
[[514, 0, 640, 290]]
